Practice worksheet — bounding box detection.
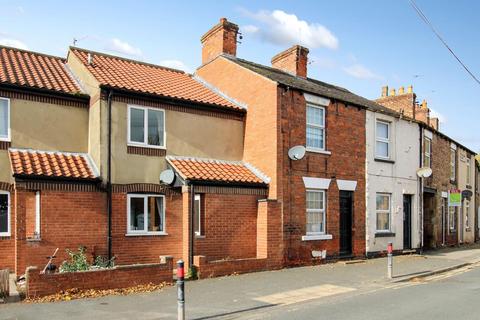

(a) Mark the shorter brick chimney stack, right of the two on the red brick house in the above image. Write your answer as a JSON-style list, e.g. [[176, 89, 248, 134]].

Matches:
[[272, 45, 308, 78]]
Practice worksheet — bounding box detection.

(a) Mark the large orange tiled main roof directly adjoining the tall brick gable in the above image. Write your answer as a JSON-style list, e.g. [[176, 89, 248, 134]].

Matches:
[[71, 48, 241, 109]]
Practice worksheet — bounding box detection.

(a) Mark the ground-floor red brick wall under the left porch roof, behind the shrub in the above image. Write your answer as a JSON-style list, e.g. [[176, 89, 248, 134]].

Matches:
[[15, 189, 107, 275]]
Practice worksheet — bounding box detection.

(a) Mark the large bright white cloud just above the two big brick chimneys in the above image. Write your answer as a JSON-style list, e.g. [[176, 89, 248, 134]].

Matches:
[[242, 10, 338, 49]]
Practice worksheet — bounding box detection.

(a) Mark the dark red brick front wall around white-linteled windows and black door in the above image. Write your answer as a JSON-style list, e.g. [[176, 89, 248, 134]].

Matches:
[[278, 89, 366, 264]]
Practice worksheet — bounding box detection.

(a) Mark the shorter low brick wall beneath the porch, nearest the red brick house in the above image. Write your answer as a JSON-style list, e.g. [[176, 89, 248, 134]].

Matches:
[[193, 256, 282, 279]]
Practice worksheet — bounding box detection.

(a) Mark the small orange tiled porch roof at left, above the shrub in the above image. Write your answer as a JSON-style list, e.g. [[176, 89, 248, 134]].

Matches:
[[9, 149, 98, 179]]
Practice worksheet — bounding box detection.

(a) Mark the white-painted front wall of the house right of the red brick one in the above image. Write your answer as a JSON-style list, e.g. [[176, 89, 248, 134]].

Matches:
[[366, 111, 421, 252]]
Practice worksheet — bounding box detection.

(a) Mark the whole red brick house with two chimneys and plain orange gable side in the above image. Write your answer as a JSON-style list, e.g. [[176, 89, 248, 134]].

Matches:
[[196, 19, 392, 265]]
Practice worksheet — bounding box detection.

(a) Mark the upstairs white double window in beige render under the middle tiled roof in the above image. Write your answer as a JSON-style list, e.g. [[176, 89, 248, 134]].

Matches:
[[127, 105, 166, 149]]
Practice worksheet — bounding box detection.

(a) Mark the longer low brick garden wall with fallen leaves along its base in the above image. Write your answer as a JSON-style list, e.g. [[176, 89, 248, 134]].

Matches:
[[26, 257, 173, 298]]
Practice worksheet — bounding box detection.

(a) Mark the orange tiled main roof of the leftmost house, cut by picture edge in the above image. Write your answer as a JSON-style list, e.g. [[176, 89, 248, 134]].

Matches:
[[0, 46, 81, 94]]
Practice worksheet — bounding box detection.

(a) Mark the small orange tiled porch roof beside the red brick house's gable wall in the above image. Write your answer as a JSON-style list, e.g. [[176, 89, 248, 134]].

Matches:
[[167, 156, 268, 184]]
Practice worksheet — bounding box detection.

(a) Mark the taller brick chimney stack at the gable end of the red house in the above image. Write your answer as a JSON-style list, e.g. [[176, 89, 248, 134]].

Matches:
[[200, 18, 238, 64]]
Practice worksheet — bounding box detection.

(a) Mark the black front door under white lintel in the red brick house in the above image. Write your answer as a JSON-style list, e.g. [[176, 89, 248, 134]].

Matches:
[[340, 191, 353, 256]]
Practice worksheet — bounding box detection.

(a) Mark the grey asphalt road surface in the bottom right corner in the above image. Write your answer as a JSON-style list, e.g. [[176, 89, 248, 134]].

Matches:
[[240, 266, 480, 320]]
